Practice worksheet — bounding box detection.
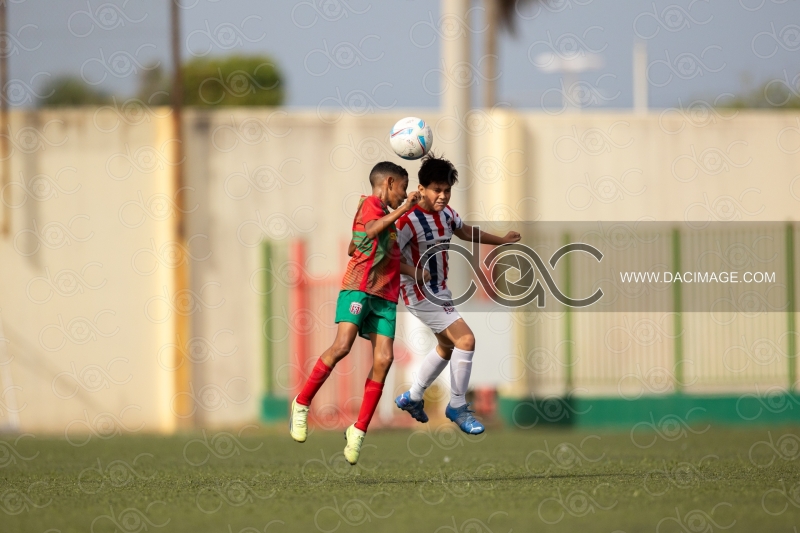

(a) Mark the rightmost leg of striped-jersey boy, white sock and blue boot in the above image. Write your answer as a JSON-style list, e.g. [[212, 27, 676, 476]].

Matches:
[[442, 318, 485, 435]]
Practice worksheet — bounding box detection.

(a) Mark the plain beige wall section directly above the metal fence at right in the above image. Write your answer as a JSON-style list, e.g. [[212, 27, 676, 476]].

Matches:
[[521, 109, 800, 221]]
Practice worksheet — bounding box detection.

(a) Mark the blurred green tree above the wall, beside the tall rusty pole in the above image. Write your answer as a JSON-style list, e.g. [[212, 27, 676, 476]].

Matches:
[[138, 56, 284, 107]]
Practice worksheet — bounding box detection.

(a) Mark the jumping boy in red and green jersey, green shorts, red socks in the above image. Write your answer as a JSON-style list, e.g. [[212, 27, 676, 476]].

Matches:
[[289, 161, 419, 464]]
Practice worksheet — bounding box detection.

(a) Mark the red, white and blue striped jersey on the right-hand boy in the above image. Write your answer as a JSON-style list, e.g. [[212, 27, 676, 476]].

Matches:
[[396, 205, 464, 305]]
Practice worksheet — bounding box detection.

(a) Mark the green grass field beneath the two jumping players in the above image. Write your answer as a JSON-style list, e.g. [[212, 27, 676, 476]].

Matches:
[[0, 425, 800, 533]]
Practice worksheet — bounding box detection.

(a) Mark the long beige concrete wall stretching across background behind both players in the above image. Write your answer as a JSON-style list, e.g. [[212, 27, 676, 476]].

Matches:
[[0, 109, 800, 435]]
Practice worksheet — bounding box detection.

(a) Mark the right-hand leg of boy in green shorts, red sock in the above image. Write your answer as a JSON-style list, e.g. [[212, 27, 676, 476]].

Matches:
[[344, 297, 397, 464]]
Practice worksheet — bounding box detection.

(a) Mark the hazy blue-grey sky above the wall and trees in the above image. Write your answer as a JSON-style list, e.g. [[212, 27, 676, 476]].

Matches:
[[8, 0, 800, 111]]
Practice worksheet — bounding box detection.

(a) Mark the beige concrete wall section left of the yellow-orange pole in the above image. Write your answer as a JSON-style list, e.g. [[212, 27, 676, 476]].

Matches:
[[0, 110, 175, 432]]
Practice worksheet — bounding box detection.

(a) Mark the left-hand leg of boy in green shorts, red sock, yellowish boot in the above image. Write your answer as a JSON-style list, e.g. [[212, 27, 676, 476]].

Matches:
[[289, 291, 368, 442]]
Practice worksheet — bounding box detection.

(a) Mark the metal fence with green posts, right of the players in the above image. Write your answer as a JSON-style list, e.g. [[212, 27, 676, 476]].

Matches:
[[514, 223, 798, 399]]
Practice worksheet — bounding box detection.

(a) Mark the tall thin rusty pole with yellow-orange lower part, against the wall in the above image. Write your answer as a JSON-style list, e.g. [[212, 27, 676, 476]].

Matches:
[[170, 0, 194, 428]]
